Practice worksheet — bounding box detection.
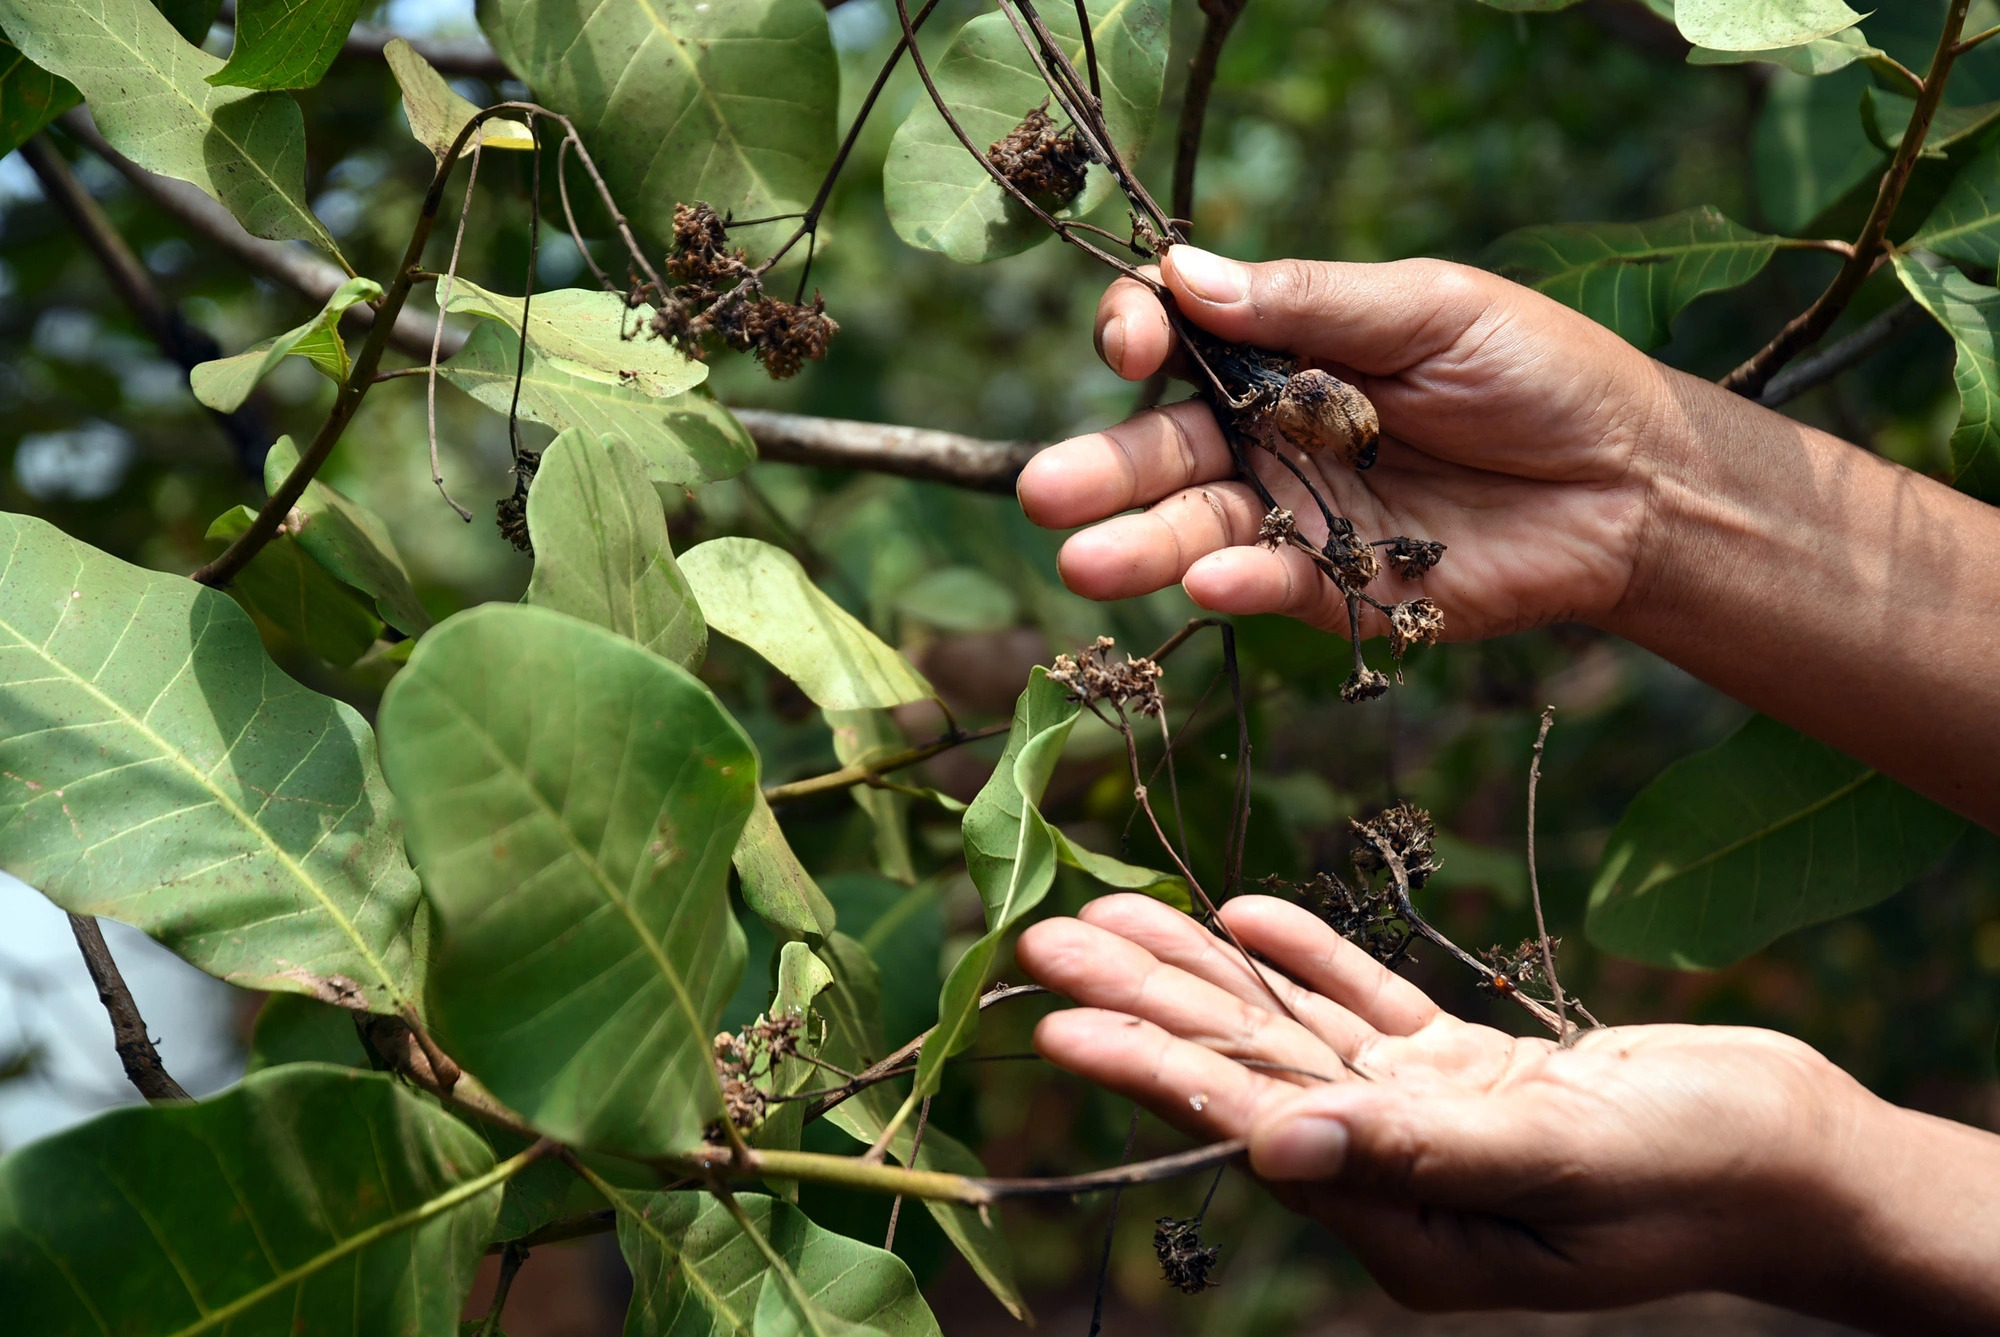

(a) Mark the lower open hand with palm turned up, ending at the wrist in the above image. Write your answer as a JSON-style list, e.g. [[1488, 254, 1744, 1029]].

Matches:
[[1016, 895, 1900, 1309]]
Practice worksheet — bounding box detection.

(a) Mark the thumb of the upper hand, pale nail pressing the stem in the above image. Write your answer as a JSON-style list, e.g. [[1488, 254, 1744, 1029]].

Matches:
[[1160, 246, 1506, 376]]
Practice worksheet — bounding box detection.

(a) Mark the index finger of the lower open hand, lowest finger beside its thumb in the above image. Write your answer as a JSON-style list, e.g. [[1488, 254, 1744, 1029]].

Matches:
[[1034, 1007, 1298, 1139]]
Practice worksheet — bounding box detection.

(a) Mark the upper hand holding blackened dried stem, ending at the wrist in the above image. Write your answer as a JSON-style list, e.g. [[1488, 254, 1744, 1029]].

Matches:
[[1018, 246, 1674, 640]]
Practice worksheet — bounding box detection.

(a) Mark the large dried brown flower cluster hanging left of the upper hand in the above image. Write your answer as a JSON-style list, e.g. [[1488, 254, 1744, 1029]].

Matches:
[[652, 202, 840, 380]]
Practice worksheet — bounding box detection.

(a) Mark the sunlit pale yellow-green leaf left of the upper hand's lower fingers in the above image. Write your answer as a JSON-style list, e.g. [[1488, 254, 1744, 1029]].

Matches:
[[680, 538, 936, 711]]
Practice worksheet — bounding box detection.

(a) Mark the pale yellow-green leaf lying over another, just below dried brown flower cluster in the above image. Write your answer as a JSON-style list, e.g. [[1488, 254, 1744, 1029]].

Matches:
[[444, 278, 708, 398]]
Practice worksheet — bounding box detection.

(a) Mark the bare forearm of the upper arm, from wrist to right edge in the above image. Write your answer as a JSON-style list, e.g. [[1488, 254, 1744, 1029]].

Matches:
[[1606, 370, 2000, 829]]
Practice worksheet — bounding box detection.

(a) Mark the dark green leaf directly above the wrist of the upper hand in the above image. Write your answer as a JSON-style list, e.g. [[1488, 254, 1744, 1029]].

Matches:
[[1486, 208, 1778, 348]]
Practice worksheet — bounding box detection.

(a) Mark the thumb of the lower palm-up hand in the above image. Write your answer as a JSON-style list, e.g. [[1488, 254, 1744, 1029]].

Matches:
[[1250, 1083, 1576, 1211]]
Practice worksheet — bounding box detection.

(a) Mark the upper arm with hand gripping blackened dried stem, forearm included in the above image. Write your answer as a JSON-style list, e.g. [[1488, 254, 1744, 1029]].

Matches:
[[1020, 248, 2000, 829]]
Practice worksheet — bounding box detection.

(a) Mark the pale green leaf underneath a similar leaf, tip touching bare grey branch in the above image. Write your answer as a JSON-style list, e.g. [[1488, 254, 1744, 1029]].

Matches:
[[440, 320, 756, 484]]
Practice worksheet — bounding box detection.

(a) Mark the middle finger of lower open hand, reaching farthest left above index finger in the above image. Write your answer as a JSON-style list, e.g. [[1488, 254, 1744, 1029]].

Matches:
[[1014, 919, 1366, 1079]]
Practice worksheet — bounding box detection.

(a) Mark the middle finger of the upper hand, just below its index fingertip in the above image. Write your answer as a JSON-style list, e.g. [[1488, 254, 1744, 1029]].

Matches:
[[1014, 400, 1236, 528]]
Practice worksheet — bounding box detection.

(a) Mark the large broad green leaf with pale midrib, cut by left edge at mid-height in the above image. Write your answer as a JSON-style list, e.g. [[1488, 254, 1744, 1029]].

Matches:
[[0, 514, 428, 1013]]
